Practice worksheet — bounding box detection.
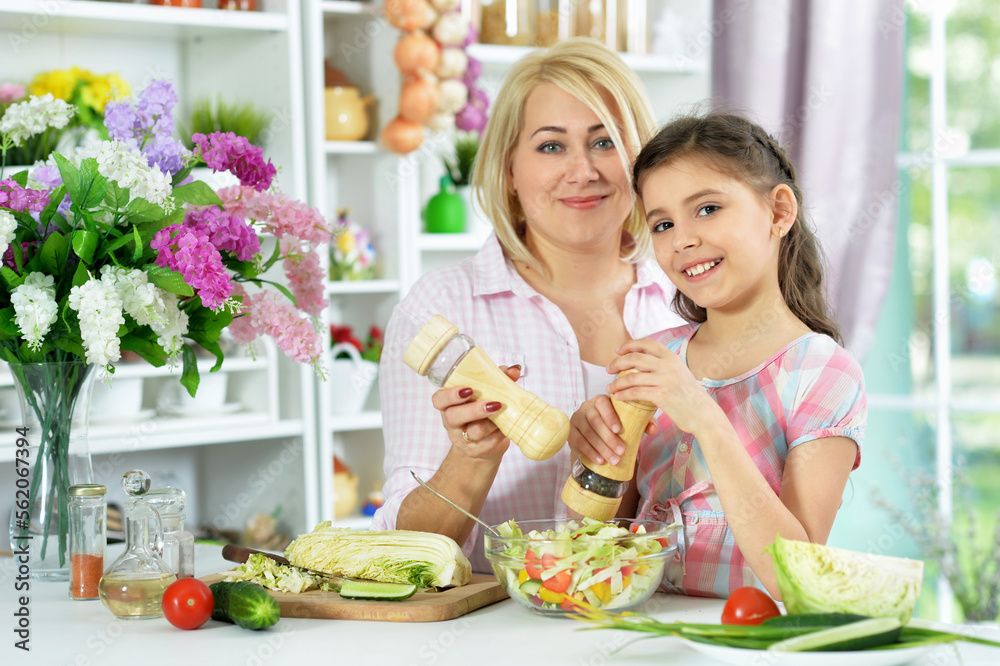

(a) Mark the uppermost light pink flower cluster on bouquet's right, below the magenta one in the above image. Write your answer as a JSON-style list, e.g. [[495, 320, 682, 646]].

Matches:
[[217, 185, 333, 243]]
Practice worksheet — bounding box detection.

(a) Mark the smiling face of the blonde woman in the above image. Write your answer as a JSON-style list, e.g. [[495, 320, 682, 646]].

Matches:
[[509, 83, 633, 251]]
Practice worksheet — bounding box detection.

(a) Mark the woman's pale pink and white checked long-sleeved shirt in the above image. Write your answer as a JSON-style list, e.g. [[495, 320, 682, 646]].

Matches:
[[373, 235, 681, 572]]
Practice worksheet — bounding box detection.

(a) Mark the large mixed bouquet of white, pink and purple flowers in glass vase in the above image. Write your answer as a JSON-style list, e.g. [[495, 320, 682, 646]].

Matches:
[[0, 81, 331, 569]]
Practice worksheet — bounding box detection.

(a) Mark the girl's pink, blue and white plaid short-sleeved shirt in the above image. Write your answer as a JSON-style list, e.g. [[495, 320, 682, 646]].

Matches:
[[636, 325, 867, 597]]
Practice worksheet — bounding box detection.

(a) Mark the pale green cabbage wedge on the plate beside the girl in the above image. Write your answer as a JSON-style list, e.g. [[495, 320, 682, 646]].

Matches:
[[766, 536, 924, 624]]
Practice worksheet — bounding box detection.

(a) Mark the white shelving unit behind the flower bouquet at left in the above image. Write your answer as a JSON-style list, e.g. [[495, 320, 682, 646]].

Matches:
[[0, 0, 319, 533]]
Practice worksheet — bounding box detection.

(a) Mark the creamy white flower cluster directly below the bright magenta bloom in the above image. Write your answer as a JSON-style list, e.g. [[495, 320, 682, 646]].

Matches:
[[101, 266, 188, 361]]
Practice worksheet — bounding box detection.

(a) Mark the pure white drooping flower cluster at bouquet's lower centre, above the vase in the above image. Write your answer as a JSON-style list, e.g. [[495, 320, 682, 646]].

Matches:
[[69, 275, 125, 367]]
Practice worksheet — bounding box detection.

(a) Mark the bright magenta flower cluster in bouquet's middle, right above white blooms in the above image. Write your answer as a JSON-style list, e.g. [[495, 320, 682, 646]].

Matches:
[[149, 224, 233, 310]]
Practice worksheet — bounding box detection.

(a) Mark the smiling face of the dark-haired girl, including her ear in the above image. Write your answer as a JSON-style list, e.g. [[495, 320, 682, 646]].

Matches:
[[641, 158, 794, 312]]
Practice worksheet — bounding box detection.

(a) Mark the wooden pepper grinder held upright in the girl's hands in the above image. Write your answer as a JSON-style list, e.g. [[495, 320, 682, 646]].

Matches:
[[562, 370, 656, 520]]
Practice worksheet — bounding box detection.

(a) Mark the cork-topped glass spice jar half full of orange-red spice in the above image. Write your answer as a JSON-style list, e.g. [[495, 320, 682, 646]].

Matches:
[[69, 484, 108, 599]]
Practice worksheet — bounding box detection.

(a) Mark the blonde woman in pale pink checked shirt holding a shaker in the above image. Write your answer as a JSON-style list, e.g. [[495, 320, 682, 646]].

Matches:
[[374, 39, 680, 571]]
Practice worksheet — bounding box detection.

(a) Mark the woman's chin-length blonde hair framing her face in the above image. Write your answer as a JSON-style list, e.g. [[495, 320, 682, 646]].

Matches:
[[472, 38, 655, 270]]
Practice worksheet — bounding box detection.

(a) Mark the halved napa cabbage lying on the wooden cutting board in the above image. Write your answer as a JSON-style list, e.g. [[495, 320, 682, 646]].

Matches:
[[285, 521, 472, 587]]
